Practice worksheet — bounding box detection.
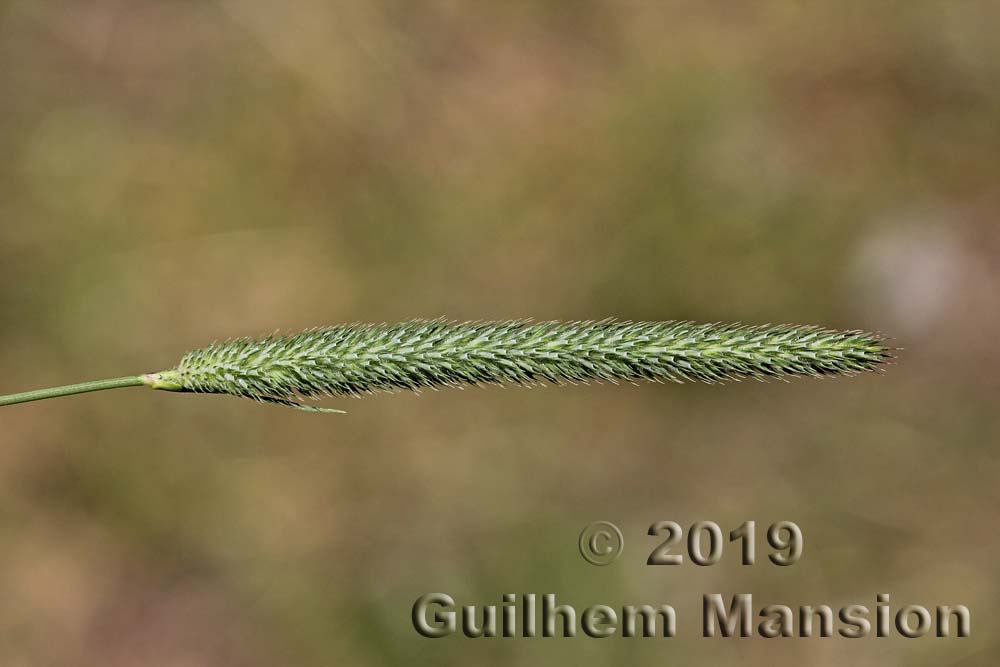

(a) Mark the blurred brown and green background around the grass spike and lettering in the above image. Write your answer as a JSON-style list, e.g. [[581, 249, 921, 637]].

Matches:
[[0, 0, 1000, 667]]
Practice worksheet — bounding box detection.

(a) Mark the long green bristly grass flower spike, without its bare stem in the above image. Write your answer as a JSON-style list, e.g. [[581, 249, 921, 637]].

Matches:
[[144, 320, 893, 411]]
